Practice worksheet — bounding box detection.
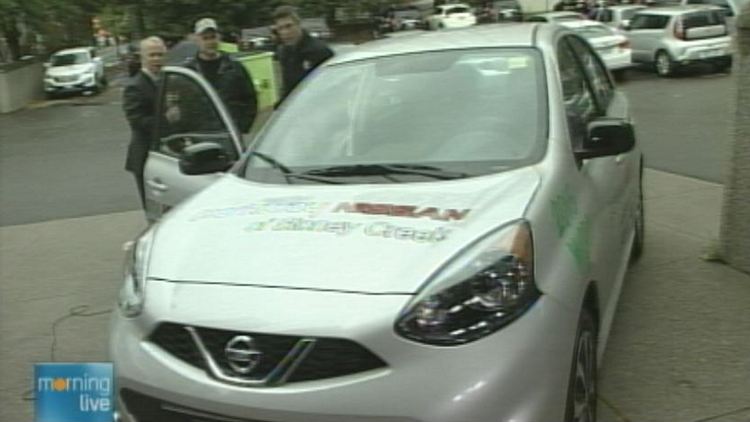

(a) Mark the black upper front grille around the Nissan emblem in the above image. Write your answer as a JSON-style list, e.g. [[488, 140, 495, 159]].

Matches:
[[149, 323, 386, 383]]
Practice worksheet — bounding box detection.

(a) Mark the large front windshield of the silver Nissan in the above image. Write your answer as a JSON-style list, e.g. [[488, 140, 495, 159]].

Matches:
[[245, 48, 547, 183]]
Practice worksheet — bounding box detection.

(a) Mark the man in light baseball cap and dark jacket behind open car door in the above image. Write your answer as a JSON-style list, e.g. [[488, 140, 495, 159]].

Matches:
[[185, 18, 258, 133]]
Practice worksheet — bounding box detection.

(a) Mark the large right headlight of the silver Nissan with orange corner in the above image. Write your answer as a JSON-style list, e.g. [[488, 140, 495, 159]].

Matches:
[[396, 221, 540, 346]]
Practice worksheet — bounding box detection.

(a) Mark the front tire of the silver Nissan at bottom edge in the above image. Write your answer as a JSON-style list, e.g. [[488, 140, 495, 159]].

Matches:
[[565, 308, 598, 422]]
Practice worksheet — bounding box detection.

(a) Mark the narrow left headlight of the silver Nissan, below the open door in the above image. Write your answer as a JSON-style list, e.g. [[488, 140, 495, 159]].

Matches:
[[117, 228, 154, 318]]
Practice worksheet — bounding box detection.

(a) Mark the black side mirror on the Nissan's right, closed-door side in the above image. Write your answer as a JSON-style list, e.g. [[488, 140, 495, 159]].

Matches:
[[575, 118, 635, 160]]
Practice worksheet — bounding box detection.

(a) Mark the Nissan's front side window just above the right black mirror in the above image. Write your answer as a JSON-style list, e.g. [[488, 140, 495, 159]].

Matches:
[[557, 39, 597, 145]]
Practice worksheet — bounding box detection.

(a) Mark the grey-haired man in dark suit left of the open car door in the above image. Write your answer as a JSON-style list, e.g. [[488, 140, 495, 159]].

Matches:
[[123, 37, 167, 209]]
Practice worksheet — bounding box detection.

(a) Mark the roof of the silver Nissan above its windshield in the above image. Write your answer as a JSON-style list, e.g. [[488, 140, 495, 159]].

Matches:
[[327, 23, 551, 65]]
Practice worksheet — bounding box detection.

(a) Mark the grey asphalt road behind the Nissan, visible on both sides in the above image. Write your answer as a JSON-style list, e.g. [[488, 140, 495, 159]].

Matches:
[[0, 64, 733, 226]]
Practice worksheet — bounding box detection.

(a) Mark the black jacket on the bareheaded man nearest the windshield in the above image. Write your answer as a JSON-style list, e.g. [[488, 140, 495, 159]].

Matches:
[[276, 32, 333, 97]]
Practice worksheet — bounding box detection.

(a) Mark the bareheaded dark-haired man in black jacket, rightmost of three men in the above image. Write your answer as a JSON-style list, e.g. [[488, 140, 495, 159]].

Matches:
[[273, 6, 333, 98]]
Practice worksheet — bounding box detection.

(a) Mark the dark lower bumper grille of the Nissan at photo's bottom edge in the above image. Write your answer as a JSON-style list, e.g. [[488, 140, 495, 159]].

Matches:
[[120, 389, 269, 422]]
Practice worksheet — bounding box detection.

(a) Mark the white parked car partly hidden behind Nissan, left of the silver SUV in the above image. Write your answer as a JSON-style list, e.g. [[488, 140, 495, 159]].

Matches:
[[559, 20, 633, 78]]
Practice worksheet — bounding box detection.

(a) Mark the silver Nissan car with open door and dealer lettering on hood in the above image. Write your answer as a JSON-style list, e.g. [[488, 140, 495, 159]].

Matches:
[[110, 24, 644, 422]]
